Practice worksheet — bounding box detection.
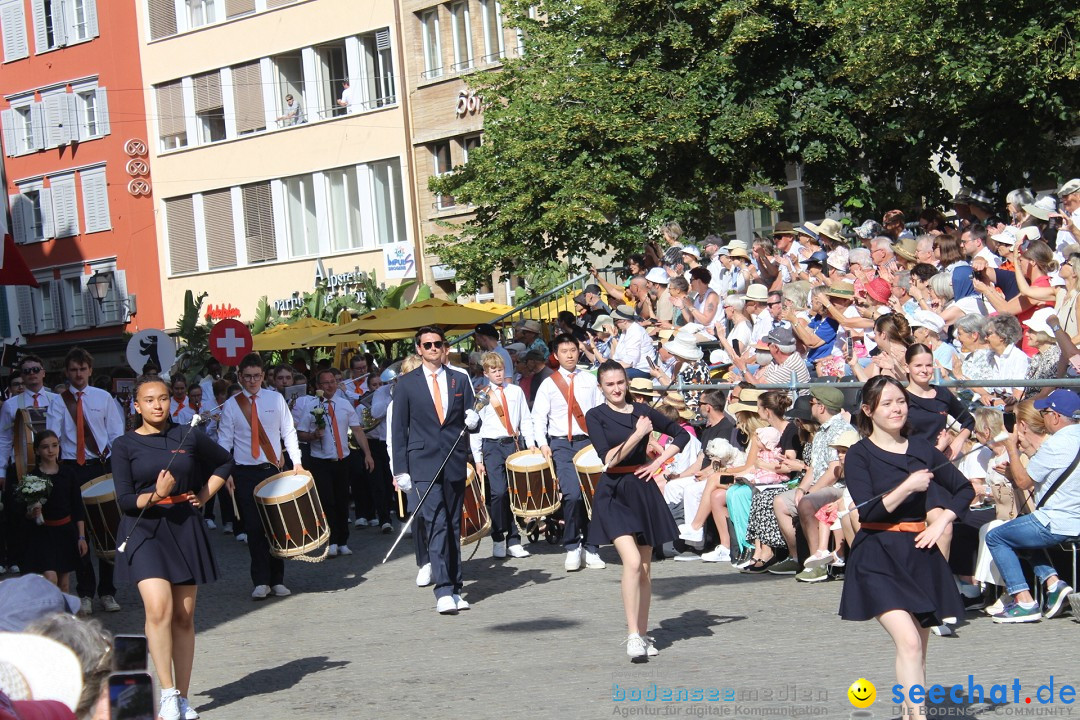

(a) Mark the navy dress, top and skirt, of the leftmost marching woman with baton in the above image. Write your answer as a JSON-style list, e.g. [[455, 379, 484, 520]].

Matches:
[[112, 424, 232, 585]]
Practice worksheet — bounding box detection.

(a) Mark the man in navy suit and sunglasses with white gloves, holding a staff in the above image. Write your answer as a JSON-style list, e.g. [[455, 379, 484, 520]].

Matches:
[[391, 326, 480, 615]]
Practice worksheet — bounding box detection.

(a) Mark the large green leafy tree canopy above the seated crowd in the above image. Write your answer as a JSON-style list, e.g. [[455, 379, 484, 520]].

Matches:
[[431, 0, 1080, 289]]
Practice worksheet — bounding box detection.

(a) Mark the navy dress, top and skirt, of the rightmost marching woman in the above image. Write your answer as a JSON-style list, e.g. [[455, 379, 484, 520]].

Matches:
[[840, 437, 975, 627]]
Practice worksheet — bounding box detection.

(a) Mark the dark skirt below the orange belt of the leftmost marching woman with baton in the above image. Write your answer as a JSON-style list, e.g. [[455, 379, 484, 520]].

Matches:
[[116, 503, 218, 585]]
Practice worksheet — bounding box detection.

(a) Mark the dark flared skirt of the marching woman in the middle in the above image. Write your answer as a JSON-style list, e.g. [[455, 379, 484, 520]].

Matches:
[[586, 473, 678, 547]]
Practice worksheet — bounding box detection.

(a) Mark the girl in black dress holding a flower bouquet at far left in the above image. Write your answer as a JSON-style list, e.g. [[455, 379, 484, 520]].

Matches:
[[23, 430, 86, 593]]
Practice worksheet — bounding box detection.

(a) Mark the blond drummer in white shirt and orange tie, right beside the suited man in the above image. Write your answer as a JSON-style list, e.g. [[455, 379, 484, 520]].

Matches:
[[470, 352, 536, 558]]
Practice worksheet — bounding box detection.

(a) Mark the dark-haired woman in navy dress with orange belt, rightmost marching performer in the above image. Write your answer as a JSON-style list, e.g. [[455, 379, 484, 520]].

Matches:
[[840, 376, 974, 717]]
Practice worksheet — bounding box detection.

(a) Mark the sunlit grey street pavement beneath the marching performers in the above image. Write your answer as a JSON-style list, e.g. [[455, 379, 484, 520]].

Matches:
[[95, 529, 1080, 720]]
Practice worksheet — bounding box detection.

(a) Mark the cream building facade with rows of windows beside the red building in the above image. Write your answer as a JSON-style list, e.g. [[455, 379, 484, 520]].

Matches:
[[136, 0, 421, 328]]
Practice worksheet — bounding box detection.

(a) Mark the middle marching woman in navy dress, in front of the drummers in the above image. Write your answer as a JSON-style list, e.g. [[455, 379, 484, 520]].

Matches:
[[585, 361, 690, 662]]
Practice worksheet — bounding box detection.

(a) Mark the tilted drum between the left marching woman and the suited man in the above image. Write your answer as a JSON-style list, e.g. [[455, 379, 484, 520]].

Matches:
[[255, 471, 330, 558]]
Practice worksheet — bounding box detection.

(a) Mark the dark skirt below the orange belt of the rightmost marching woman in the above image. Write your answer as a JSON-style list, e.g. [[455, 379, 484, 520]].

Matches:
[[840, 530, 964, 627]]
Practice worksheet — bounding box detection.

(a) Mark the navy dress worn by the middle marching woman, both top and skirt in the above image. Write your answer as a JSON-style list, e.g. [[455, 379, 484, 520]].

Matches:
[[585, 403, 690, 547]]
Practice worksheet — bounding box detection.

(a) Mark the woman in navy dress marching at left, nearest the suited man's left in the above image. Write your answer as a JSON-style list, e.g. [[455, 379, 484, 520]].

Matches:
[[112, 377, 232, 720]]
